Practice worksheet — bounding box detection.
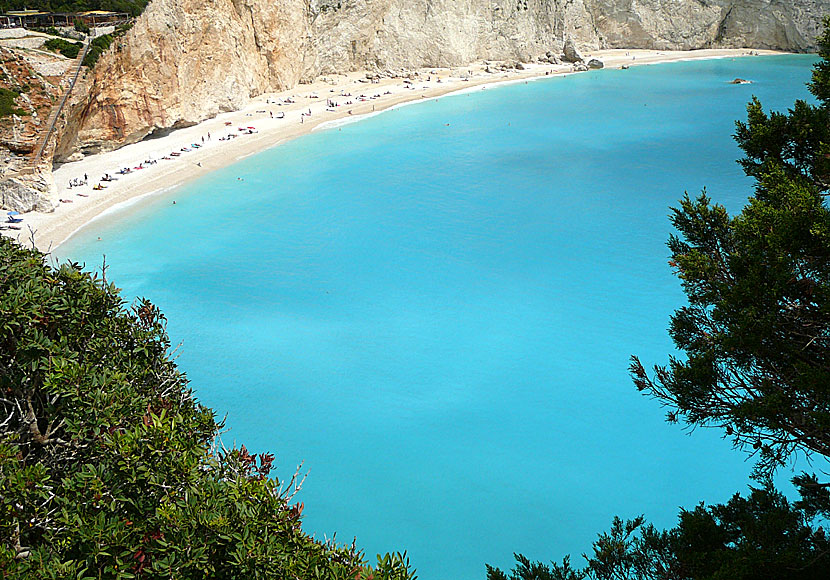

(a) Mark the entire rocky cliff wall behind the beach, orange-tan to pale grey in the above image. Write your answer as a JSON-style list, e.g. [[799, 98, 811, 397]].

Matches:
[[56, 0, 830, 159]]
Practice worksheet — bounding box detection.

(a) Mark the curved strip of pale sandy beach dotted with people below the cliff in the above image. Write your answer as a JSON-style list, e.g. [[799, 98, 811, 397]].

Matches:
[[2, 49, 776, 251]]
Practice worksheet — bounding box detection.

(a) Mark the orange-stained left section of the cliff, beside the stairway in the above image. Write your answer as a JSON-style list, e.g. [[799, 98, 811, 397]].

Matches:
[[58, 0, 308, 156]]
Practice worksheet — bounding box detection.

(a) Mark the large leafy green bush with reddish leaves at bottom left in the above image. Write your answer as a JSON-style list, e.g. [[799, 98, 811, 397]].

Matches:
[[0, 238, 414, 580]]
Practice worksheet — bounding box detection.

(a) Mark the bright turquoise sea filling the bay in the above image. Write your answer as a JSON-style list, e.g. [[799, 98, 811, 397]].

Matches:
[[56, 56, 814, 580]]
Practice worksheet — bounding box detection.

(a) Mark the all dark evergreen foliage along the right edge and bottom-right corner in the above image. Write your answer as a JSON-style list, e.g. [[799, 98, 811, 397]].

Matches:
[[487, 18, 830, 580]]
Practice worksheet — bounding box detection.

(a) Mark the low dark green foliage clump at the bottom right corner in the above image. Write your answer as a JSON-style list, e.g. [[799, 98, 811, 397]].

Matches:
[[487, 486, 830, 580]]
